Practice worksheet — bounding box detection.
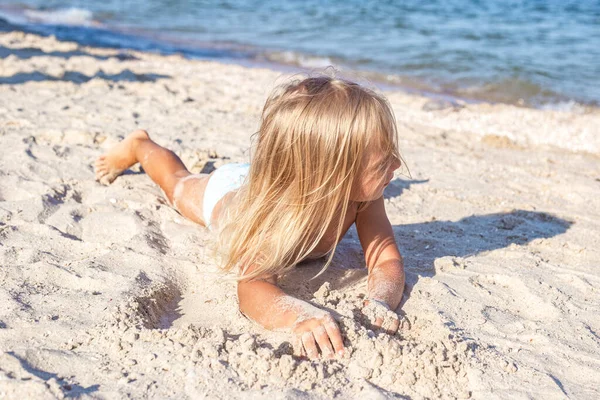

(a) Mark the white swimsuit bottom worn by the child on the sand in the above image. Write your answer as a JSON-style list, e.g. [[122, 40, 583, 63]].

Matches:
[[202, 163, 250, 228]]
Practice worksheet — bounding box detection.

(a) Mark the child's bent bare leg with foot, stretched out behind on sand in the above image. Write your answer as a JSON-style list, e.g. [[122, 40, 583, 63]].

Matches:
[[95, 130, 210, 225]]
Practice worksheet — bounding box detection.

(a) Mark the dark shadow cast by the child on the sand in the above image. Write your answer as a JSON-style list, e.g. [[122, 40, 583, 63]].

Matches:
[[281, 181, 573, 299]]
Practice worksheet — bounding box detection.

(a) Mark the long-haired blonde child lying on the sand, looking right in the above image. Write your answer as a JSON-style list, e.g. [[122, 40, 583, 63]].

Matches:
[[96, 77, 404, 358]]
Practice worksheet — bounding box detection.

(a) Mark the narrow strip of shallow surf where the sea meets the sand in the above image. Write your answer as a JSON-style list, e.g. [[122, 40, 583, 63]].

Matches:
[[0, 9, 600, 113]]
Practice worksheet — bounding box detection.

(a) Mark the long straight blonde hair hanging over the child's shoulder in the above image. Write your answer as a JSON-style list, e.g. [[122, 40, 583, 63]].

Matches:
[[217, 76, 400, 279]]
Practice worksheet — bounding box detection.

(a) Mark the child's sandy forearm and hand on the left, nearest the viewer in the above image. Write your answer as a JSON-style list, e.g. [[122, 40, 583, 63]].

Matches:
[[238, 278, 344, 359]]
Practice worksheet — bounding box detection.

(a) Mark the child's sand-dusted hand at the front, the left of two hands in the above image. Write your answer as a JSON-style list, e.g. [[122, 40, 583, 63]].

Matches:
[[292, 312, 344, 360]]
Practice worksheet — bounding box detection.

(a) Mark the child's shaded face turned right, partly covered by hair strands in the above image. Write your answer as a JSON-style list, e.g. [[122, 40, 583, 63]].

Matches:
[[350, 145, 401, 201]]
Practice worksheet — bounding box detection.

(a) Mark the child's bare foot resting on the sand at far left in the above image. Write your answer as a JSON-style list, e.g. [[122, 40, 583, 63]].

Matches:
[[94, 130, 150, 185]]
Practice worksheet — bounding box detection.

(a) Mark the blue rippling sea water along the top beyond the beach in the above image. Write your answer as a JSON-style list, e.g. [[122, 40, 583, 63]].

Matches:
[[0, 0, 600, 109]]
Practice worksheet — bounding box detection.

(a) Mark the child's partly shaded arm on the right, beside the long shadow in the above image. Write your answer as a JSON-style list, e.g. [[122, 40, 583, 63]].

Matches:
[[356, 197, 405, 332]]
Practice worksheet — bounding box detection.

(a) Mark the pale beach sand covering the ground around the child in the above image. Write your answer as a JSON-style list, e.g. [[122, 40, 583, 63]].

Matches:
[[0, 32, 600, 399]]
